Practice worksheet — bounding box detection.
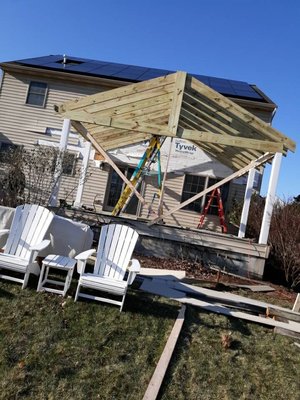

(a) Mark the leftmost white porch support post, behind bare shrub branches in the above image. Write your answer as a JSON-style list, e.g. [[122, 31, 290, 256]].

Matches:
[[49, 119, 71, 207]]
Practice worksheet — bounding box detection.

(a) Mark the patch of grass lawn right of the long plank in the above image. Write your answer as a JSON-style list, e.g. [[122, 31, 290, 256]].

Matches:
[[160, 296, 300, 400]]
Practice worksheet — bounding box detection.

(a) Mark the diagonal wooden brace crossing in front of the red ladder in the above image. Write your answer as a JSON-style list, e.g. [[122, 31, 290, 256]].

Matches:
[[147, 153, 273, 226]]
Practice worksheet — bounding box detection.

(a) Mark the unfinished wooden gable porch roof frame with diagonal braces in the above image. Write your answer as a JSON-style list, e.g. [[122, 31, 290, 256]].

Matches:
[[55, 72, 296, 224]]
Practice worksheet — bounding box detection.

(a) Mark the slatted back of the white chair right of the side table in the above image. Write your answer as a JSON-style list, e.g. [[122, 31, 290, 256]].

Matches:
[[94, 224, 139, 280]]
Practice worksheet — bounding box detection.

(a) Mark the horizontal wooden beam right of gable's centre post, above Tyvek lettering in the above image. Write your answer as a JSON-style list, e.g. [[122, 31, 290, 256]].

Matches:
[[179, 128, 283, 153]]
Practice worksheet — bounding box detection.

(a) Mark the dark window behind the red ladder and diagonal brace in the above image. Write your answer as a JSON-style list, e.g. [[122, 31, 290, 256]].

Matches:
[[181, 175, 229, 215]]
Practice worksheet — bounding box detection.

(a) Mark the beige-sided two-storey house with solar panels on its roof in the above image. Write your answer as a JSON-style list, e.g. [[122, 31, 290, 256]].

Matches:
[[0, 55, 282, 230]]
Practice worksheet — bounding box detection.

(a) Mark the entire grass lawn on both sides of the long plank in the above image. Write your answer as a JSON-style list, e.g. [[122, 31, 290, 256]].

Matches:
[[0, 281, 300, 400]]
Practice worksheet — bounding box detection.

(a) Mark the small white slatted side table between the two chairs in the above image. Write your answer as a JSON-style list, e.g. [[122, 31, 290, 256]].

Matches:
[[37, 254, 76, 296]]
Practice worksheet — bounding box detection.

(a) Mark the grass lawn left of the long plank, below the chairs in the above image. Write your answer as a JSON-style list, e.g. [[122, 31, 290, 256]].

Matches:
[[0, 281, 178, 400]]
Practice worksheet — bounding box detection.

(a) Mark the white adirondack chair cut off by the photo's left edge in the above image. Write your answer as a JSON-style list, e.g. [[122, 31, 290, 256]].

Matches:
[[0, 204, 54, 289]]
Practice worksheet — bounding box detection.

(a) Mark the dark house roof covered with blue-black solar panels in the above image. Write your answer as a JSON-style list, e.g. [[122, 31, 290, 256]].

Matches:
[[12, 54, 266, 102]]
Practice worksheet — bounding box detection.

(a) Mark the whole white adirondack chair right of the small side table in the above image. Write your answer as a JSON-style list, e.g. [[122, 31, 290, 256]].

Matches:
[[75, 224, 140, 311]]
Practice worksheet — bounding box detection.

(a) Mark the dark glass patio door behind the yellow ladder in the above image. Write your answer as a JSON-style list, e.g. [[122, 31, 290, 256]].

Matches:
[[105, 168, 139, 215]]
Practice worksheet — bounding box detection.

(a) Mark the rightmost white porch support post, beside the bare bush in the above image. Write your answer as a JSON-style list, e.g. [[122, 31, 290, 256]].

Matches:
[[258, 153, 282, 244]]
